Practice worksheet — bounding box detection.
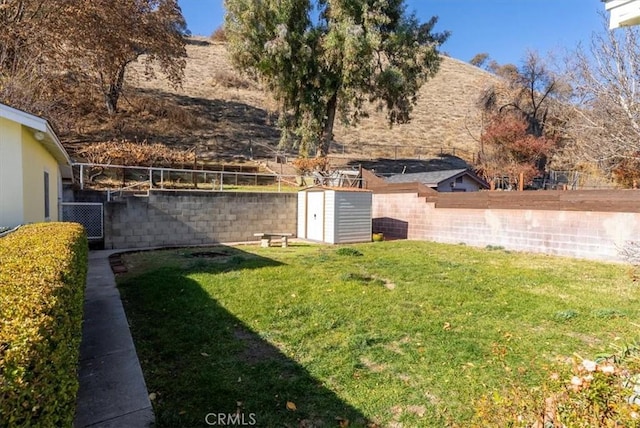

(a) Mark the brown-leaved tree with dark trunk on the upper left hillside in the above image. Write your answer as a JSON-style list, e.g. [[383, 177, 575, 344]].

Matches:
[[62, 0, 187, 115]]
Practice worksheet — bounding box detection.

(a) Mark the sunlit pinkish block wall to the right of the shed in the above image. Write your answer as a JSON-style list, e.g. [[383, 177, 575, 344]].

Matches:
[[373, 193, 640, 261]]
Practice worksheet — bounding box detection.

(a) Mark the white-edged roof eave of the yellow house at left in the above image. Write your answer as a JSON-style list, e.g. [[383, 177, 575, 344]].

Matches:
[[0, 103, 73, 179]]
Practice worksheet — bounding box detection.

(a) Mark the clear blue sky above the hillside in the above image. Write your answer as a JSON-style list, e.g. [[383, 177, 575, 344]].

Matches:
[[178, 0, 604, 65]]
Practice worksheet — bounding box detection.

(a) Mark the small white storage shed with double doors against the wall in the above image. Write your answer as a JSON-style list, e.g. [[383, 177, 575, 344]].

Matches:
[[297, 187, 373, 244]]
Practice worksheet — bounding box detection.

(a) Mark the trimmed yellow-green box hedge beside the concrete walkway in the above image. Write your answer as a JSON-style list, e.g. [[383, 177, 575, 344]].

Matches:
[[0, 223, 88, 427]]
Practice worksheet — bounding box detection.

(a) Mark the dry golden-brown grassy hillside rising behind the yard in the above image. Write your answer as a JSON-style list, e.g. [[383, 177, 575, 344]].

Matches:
[[123, 38, 496, 166]]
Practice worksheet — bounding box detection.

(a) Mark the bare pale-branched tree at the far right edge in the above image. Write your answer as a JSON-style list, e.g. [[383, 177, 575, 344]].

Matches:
[[566, 17, 640, 179]]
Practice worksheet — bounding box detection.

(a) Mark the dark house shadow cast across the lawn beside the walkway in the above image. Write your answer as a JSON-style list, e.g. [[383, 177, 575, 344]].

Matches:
[[119, 247, 368, 427]]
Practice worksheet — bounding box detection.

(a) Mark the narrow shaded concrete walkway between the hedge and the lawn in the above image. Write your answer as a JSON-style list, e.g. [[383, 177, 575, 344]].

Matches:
[[74, 251, 155, 428]]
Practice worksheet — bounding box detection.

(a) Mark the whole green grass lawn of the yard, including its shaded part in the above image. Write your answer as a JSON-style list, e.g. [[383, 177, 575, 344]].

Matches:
[[118, 241, 640, 427]]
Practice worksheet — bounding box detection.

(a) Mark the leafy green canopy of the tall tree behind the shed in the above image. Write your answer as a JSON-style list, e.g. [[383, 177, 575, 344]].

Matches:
[[225, 0, 449, 156]]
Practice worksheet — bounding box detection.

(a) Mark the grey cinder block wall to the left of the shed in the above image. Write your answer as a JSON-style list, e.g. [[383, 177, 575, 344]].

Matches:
[[105, 191, 298, 249]]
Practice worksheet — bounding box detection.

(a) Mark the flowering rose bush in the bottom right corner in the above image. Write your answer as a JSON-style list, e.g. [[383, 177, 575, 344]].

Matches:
[[467, 342, 640, 428]]
